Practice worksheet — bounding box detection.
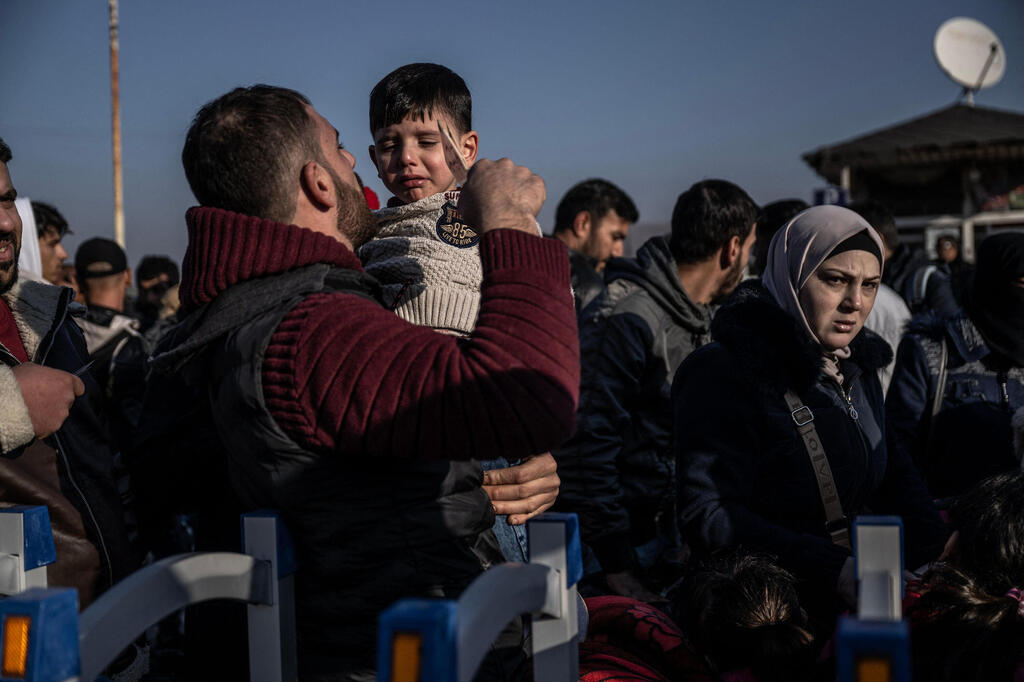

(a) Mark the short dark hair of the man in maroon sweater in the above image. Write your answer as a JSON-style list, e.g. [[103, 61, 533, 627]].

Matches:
[[181, 85, 322, 221]]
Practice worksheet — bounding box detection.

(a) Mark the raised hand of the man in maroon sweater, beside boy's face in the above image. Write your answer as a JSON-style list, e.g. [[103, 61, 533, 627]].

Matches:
[[459, 159, 547, 235]]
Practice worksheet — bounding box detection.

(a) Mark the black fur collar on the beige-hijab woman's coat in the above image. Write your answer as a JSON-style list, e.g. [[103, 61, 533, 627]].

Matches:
[[711, 281, 893, 393]]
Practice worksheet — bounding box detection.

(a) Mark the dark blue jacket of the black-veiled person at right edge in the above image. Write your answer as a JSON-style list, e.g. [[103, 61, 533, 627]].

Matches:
[[886, 313, 1024, 498]]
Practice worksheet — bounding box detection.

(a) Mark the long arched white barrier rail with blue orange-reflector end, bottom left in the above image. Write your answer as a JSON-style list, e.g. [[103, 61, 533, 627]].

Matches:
[[0, 512, 297, 682]]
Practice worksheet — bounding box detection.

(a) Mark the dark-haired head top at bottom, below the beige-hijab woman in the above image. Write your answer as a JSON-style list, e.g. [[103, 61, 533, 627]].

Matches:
[[678, 552, 814, 682]]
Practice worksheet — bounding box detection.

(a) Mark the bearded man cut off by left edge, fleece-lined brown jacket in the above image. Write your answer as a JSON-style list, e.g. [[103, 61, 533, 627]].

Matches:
[[0, 134, 135, 607]]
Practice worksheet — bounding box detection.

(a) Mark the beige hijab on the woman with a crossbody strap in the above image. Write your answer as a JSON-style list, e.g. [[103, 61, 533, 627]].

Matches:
[[762, 201, 885, 383]]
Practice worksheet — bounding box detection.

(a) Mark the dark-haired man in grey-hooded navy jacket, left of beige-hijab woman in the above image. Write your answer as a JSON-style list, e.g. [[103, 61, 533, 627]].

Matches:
[[553, 180, 758, 601]]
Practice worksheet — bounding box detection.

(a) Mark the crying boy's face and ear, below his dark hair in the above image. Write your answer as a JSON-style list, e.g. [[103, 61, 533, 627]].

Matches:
[[370, 110, 477, 204]]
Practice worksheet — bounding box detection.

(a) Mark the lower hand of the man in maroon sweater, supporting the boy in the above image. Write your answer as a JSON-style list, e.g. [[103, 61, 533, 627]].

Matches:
[[483, 453, 561, 525]]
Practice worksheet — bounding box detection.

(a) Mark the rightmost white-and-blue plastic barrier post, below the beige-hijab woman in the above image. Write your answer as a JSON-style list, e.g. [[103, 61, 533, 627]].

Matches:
[[836, 516, 910, 682]]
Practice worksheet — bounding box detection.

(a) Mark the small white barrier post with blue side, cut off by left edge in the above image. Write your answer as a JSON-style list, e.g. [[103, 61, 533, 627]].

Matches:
[[0, 507, 57, 595]]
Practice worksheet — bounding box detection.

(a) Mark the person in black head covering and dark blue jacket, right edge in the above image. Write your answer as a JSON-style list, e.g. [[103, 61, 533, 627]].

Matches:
[[886, 232, 1024, 498]]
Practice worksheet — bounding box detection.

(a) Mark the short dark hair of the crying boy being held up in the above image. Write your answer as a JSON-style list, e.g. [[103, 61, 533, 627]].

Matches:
[[370, 63, 473, 135]]
